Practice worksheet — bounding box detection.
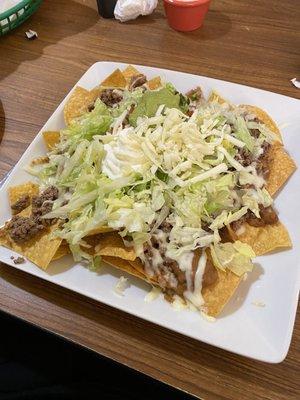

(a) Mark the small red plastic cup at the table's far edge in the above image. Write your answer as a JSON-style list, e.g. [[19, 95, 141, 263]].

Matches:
[[164, 0, 211, 32]]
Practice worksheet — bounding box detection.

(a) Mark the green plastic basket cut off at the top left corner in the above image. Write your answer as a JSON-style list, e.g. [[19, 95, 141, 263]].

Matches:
[[0, 0, 43, 36]]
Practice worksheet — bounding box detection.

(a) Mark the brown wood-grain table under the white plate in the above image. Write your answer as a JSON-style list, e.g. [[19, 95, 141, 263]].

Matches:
[[0, 0, 300, 400]]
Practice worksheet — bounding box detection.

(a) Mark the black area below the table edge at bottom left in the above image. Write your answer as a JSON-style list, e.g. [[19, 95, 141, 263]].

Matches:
[[0, 311, 193, 400]]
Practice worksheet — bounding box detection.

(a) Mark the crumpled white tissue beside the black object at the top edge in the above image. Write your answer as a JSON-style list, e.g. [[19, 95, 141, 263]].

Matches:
[[114, 0, 158, 22]]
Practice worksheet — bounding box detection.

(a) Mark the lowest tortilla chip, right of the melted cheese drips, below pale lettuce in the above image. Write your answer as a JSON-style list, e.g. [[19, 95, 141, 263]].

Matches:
[[202, 269, 242, 317]]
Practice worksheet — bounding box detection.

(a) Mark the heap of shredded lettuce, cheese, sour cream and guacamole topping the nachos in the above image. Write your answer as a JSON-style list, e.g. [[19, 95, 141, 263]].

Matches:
[[30, 84, 272, 268]]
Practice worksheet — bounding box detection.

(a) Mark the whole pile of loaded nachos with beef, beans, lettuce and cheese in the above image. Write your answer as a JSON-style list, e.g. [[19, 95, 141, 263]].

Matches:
[[0, 66, 296, 316]]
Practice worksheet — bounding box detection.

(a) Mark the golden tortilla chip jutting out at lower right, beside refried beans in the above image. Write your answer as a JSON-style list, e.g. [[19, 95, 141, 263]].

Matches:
[[228, 221, 292, 256]]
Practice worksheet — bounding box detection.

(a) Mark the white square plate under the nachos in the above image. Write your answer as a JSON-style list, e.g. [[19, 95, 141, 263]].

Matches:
[[0, 62, 300, 363]]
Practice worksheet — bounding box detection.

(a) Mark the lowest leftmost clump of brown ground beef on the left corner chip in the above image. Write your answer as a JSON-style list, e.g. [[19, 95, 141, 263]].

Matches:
[[7, 215, 44, 243]]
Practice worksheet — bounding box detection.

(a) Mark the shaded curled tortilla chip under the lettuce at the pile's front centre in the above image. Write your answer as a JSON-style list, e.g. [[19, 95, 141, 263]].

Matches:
[[95, 232, 136, 261]]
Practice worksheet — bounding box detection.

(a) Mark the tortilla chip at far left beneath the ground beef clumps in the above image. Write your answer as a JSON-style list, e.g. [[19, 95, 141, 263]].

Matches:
[[0, 219, 62, 270]]
